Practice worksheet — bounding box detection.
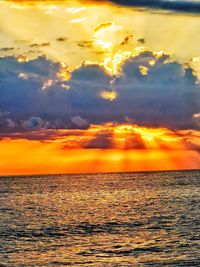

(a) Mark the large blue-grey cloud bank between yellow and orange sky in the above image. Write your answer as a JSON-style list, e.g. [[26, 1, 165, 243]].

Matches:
[[0, 52, 200, 135]]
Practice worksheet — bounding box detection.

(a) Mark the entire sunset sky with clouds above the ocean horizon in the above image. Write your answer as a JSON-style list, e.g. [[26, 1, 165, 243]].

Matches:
[[0, 0, 200, 175]]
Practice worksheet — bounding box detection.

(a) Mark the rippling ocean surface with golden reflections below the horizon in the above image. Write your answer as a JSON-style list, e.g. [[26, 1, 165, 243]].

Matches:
[[0, 171, 200, 267]]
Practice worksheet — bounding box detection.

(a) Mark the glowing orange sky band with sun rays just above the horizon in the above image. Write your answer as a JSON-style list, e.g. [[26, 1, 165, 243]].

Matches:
[[0, 124, 200, 177]]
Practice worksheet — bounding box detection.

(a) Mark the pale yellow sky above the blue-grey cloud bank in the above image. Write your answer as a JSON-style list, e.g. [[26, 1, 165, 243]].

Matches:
[[0, 1, 200, 77]]
